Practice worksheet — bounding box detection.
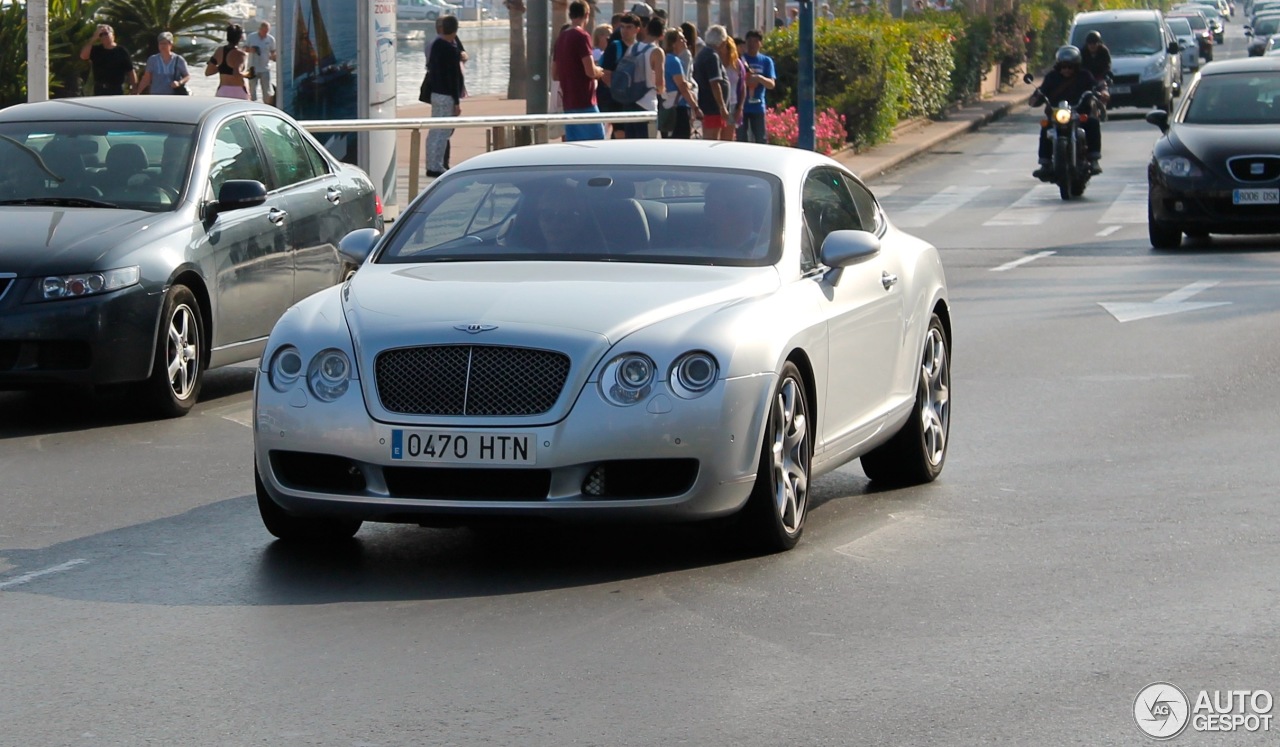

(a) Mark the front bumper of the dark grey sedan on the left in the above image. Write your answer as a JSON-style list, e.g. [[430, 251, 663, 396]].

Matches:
[[0, 278, 163, 389]]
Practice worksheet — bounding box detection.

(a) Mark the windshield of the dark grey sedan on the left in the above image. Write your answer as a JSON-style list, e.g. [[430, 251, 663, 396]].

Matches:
[[0, 122, 195, 211]]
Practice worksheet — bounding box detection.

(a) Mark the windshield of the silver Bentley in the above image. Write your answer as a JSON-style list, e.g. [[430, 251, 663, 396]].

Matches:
[[375, 166, 782, 267]]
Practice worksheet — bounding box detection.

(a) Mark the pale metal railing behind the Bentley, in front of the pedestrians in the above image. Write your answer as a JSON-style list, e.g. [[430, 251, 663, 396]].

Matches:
[[298, 111, 658, 194]]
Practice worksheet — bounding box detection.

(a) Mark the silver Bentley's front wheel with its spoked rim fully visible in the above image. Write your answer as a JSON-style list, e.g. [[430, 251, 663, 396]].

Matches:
[[740, 362, 813, 553]]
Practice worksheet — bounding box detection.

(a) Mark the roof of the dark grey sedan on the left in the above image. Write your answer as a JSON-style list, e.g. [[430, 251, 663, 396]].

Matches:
[[0, 96, 280, 125]]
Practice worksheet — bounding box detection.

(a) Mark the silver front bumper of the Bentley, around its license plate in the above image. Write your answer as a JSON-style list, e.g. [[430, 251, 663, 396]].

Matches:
[[253, 374, 777, 523]]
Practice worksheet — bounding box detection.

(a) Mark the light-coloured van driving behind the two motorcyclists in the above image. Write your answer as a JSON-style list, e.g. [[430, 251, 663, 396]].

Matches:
[[1068, 10, 1183, 111]]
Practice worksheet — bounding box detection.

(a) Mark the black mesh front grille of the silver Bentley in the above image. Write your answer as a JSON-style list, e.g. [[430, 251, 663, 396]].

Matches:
[[375, 345, 570, 416]]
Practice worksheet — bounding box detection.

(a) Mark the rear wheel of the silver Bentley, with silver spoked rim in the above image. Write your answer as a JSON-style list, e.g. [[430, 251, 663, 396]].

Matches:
[[861, 313, 951, 485]]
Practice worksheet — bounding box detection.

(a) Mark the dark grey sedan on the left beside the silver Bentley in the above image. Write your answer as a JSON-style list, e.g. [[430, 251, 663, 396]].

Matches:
[[0, 96, 383, 417]]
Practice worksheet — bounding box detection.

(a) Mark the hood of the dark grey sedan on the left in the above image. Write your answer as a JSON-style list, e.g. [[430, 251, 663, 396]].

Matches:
[[0, 206, 157, 278]]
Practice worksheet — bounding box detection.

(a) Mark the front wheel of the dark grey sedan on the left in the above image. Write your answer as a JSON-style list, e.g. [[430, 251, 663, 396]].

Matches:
[[141, 285, 209, 417]]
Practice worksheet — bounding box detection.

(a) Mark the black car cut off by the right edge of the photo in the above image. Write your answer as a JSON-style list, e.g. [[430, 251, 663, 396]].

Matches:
[[1147, 56, 1280, 249]]
